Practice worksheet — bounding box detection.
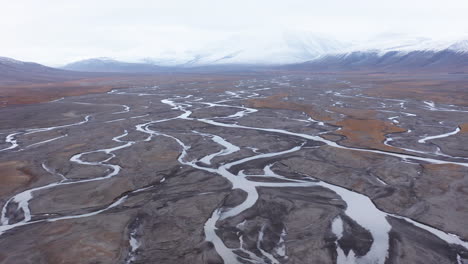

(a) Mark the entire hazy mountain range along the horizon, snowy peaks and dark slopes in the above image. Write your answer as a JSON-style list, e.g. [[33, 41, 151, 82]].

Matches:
[[0, 31, 468, 78]]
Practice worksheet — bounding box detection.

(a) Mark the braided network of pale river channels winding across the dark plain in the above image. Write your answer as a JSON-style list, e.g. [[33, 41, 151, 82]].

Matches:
[[0, 83, 468, 264]]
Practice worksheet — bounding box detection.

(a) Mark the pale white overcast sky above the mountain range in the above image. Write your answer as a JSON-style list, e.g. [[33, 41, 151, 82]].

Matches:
[[0, 0, 468, 66]]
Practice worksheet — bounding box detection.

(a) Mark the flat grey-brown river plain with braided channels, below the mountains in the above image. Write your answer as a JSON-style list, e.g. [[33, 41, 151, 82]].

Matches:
[[0, 72, 468, 264]]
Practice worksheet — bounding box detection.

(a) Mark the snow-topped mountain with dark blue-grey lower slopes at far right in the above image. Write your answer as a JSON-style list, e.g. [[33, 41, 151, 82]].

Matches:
[[285, 34, 468, 72]]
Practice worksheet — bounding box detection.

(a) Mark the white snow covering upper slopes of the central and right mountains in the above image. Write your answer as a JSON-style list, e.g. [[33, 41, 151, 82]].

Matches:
[[60, 30, 468, 67]]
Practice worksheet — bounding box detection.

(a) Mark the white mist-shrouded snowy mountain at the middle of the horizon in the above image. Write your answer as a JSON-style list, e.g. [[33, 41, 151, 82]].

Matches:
[[176, 31, 347, 65]]
